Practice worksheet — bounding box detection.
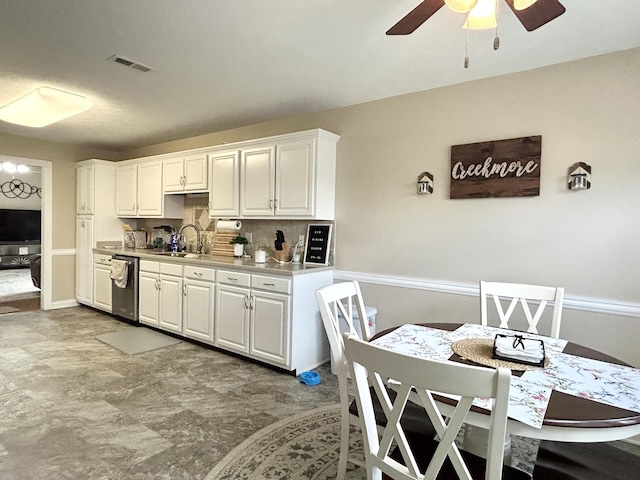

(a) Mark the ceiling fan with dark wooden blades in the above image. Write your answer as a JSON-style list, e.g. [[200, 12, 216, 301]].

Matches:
[[387, 0, 565, 35]]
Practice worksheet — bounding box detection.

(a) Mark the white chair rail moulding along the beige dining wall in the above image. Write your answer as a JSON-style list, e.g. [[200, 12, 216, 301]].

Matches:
[[333, 270, 640, 318]]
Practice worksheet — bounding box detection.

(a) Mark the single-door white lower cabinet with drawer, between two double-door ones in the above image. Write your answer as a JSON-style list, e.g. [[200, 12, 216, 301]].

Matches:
[[182, 265, 215, 343]]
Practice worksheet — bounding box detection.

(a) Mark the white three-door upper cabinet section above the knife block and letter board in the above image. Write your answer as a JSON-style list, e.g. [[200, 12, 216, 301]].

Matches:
[[209, 129, 340, 220]]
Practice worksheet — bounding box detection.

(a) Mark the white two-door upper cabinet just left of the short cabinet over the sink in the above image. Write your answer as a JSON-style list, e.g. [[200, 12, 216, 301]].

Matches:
[[116, 160, 184, 218]]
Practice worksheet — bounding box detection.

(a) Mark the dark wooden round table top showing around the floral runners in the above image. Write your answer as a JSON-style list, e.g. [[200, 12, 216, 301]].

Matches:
[[373, 323, 640, 428]]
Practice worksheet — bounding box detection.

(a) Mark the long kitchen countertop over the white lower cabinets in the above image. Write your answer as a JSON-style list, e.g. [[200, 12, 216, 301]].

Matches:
[[93, 245, 334, 276]]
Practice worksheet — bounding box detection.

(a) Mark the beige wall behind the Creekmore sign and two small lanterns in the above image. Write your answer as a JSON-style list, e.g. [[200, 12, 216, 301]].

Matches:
[[126, 49, 640, 365]]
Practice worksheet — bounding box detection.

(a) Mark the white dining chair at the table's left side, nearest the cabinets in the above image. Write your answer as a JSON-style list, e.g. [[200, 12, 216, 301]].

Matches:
[[316, 282, 435, 480]]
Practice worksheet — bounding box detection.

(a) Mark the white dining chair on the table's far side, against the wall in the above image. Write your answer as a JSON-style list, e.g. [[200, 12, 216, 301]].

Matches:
[[480, 281, 564, 338]]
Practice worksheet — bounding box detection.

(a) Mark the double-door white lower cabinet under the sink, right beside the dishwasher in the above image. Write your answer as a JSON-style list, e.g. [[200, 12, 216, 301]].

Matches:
[[139, 260, 183, 333]]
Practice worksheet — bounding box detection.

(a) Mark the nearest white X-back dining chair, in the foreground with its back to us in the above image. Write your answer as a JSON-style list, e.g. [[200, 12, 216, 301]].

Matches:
[[344, 334, 530, 480]]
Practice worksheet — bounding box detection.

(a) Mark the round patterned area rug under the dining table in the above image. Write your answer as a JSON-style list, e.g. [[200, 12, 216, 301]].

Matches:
[[205, 405, 366, 480]]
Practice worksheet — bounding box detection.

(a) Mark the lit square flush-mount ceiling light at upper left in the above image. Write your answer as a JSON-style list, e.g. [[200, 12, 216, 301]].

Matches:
[[0, 87, 93, 127]]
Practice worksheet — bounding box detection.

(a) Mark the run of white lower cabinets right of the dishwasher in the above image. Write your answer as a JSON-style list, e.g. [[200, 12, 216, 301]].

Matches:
[[134, 260, 333, 374]]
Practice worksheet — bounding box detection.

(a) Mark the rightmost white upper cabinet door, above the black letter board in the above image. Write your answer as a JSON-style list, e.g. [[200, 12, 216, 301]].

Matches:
[[275, 138, 316, 217]]
